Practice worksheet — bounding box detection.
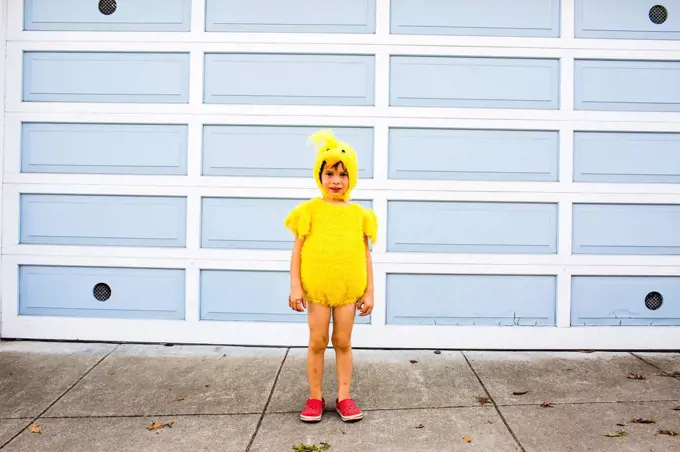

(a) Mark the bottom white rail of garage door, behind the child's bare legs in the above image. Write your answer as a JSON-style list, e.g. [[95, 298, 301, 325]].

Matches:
[[5, 312, 680, 350]]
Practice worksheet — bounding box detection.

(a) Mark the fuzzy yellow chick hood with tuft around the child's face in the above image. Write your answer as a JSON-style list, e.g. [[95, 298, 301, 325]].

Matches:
[[309, 129, 359, 201]]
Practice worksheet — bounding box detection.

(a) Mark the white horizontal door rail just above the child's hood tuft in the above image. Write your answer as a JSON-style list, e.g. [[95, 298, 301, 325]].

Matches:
[[7, 104, 680, 127]]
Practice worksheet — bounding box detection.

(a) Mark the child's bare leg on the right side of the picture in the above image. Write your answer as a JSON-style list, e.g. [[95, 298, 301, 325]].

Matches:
[[332, 304, 356, 401]]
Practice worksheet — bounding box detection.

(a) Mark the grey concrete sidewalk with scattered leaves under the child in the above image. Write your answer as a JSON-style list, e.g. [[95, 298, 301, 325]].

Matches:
[[0, 342, 680, 452]]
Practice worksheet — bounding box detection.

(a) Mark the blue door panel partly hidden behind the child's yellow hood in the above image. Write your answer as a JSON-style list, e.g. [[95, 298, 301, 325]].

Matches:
[[203, 125, 373, 179]]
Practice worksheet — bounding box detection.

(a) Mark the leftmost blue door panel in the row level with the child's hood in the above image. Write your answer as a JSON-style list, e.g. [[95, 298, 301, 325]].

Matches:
[[21, 123, 188, 175]]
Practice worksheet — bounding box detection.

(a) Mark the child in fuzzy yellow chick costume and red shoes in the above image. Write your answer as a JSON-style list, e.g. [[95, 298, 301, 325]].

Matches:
[[284, 130, 378, 422]]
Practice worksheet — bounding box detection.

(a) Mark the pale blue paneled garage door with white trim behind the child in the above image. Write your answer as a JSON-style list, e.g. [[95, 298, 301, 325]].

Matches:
[[2, 0, 680, 349]]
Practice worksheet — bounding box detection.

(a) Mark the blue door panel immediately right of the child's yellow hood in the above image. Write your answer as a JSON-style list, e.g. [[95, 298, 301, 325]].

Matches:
[[389, 128, 559, 181]]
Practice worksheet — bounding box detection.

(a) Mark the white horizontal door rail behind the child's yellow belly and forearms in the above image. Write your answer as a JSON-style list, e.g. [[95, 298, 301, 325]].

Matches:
[[3, 247, 680, 276]]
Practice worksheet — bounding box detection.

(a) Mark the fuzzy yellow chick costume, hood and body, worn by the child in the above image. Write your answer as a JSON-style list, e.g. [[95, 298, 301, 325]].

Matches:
[[284, 130, 378, 307]]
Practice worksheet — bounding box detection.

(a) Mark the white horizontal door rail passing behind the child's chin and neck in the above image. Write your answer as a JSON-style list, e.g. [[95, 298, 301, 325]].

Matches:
[[5, 176, 680, 197]]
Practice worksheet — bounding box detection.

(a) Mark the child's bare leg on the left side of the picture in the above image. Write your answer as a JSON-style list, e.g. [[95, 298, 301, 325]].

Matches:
[[307, 303, 331, 400]]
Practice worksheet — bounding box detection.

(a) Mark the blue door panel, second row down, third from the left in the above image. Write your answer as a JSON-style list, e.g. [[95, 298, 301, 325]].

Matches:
[[390, 56, 559, 110]]
